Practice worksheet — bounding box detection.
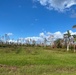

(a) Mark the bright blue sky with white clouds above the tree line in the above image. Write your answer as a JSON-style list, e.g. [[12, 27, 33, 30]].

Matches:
[[0, 0, 76, 39]]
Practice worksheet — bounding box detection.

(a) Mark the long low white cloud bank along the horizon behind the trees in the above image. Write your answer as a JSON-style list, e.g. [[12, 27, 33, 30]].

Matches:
[[4, 30, 76, 43]]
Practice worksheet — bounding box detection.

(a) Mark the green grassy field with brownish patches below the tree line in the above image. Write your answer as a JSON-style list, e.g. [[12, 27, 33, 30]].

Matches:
[[0, 47, 76, 75]]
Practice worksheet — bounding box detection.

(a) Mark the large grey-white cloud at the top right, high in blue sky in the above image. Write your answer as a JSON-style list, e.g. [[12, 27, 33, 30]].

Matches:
[[37, 0, 76, 12]]
